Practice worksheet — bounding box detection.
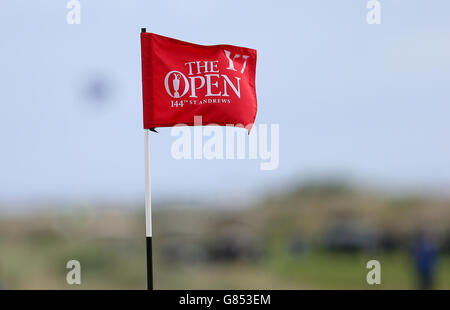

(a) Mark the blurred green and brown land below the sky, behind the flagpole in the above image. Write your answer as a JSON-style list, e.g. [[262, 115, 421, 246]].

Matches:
[[0, 182, 450, 289]]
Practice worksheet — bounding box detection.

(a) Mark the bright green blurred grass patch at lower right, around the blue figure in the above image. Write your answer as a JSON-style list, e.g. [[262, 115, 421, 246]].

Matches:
[[273, 251, 450, 289]]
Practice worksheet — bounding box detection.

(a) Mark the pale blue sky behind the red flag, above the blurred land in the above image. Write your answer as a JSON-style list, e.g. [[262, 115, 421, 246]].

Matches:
[[0, 0, 450, 206]]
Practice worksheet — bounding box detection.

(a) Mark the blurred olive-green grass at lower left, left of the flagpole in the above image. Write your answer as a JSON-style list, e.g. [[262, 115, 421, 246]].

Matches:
[[0, 238, 146, 289]]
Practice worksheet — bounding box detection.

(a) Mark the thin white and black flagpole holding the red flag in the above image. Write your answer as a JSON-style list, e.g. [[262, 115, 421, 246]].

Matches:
[[141, 28, 153, 290]]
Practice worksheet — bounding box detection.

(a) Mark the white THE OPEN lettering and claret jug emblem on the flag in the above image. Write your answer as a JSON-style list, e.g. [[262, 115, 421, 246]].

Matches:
[[164, 49, 250, 107]]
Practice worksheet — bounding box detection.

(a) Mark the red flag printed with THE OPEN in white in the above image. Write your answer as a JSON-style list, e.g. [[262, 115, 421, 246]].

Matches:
[[141, 32, 256, 132]]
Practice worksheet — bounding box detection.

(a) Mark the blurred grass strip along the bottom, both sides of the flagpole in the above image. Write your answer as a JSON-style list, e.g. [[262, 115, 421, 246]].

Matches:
[[0, 229, 450, 289]]
